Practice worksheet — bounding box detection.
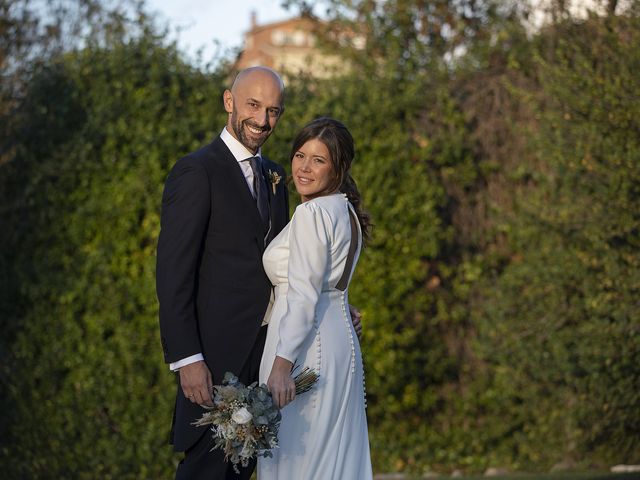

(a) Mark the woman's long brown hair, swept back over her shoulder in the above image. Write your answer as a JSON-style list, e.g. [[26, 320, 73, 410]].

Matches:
[[289, 117, 371, 240]]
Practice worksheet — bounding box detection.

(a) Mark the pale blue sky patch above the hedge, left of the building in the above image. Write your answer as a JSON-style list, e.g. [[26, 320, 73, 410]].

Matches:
[[146, 0, 293, 60]]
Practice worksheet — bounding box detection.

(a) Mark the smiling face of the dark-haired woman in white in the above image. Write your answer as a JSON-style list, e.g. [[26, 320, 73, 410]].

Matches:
[[291, 138, 335, 202]]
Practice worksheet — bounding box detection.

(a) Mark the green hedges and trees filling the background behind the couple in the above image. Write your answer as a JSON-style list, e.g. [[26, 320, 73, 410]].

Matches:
[[0, 0, 640, 479]]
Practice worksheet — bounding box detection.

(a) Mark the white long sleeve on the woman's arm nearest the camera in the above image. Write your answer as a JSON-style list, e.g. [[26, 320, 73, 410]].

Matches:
[[276, 201, 332, 363]]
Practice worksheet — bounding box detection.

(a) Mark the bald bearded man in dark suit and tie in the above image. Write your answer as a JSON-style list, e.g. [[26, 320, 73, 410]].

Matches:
[[156, 67, 288, 480]]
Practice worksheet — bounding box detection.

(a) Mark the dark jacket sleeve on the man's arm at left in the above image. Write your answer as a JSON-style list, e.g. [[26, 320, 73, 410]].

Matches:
[[156, 157, 211, 363]]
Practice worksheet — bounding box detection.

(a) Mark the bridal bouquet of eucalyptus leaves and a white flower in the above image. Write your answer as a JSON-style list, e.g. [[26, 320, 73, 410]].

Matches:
[[194, 367, 318, 473]]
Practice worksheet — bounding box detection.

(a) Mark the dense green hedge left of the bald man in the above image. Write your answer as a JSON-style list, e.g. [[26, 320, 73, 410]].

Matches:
[[0, 8, 234, 478]]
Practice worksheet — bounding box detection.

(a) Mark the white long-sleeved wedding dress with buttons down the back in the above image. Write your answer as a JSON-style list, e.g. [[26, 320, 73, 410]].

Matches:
[[258, 194, 372, 480]]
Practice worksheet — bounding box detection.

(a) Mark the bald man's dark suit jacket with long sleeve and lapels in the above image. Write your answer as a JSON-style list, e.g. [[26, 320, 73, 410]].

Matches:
[[156, 137, 289, 451]]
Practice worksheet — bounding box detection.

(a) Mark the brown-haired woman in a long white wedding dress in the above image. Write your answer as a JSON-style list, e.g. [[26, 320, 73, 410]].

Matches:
[[258, 117, 372, 480]]
